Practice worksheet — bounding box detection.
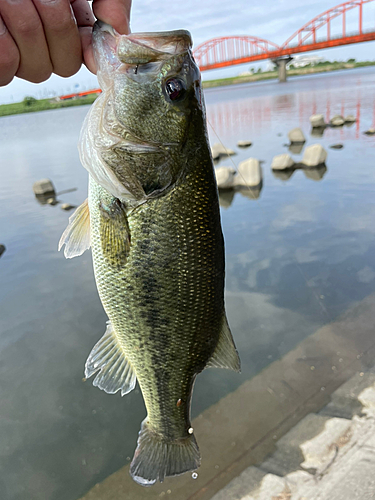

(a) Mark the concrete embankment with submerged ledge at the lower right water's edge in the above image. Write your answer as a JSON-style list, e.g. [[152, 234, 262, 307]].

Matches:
[[82, 295, 375, 500]]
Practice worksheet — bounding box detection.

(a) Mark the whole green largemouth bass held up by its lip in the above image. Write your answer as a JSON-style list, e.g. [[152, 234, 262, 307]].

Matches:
[[59, 22, 240, 486]]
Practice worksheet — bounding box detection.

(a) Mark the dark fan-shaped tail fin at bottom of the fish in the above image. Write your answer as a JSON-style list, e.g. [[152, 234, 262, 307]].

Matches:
[[130, 420, 200, 486]]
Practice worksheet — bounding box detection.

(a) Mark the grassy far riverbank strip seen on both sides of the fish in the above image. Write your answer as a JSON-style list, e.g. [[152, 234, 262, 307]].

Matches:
[[0, 61, 375, 117]]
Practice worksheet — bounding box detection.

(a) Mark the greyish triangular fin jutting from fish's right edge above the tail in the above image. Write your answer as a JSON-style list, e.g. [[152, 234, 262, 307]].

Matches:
[[206, 313, 241, 372]]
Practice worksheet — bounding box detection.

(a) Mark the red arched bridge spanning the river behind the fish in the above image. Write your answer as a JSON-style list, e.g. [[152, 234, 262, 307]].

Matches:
[[194, 0, 375, 80]]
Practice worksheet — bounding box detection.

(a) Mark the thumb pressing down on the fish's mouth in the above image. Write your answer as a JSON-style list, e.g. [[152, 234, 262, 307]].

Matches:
[[92, 0, 131, 35]]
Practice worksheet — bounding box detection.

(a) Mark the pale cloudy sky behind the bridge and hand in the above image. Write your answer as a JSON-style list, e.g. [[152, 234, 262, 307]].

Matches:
[[0, 0, 375, 104]]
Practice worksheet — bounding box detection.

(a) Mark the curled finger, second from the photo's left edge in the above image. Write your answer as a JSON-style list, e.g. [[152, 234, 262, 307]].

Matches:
[[0, 0, 52, 83]]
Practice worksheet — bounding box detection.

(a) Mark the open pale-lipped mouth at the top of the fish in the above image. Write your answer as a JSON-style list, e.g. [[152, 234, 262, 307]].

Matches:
[[93, 21, 193, 64]]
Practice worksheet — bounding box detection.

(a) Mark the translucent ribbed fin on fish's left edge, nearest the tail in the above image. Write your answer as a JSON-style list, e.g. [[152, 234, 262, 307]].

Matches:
[[85, 321, 137, 396]]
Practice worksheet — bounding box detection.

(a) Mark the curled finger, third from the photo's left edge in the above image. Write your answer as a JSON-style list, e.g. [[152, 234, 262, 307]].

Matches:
[[32, 0, 82, 77]]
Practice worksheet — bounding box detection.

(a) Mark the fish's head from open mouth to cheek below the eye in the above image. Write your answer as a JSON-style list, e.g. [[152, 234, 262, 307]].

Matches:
[[93, 22, 204, 150]]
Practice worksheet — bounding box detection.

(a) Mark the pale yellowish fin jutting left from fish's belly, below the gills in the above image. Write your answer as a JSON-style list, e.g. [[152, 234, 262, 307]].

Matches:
[[59, 199, 91, 259]]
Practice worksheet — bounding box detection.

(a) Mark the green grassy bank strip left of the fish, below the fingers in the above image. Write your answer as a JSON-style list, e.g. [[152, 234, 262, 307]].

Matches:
[[0, 94, 96, 116]]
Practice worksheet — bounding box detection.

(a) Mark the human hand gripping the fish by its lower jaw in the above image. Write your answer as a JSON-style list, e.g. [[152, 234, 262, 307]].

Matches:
[[0, 0, 131, 86]]
